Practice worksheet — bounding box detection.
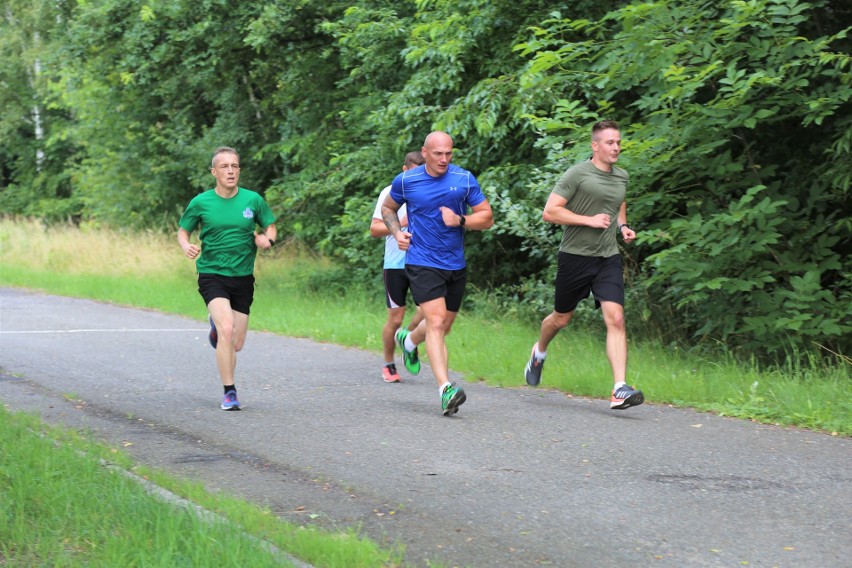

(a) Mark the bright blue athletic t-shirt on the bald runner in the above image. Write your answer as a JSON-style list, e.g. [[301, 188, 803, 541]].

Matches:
[[390, 164, 485, 270]]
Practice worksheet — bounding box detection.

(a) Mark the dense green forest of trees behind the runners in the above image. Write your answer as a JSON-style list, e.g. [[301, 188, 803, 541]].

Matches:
[[0, 0, 852, 365]]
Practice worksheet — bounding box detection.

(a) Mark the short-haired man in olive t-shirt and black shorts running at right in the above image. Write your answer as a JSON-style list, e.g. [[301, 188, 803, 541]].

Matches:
[[524, 120, 645, 410]]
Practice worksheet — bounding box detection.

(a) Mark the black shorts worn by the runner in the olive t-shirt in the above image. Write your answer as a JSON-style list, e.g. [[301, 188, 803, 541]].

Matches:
[[553, 251, 624, 314]]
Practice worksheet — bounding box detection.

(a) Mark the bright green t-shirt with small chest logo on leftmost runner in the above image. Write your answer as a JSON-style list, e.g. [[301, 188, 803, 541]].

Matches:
[[180, 187, 275, 276]]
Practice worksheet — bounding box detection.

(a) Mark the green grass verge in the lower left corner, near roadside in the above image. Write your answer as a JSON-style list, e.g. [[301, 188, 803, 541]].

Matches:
[[0, 407, 401, 568]]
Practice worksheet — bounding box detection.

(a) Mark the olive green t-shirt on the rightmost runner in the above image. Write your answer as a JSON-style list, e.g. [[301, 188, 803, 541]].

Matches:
[[553, 160, 628, 258]]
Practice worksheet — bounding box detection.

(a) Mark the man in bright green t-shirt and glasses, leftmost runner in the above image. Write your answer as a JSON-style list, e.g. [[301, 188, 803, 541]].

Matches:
[[177, 147, 278, 410]]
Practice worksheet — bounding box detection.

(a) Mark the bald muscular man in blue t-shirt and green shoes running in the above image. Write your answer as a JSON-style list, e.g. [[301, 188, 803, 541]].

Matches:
[[382, 131, 494, 416]]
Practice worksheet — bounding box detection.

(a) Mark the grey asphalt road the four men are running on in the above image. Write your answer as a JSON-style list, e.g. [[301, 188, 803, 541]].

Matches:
[[0, 289, 852, 567]]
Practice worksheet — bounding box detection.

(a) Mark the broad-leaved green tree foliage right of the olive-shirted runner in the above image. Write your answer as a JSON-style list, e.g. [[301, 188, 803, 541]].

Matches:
[[523, 0, 852, 354]]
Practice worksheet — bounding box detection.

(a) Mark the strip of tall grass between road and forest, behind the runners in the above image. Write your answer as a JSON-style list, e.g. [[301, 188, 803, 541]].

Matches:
[[0, 221, 852, 436]]
